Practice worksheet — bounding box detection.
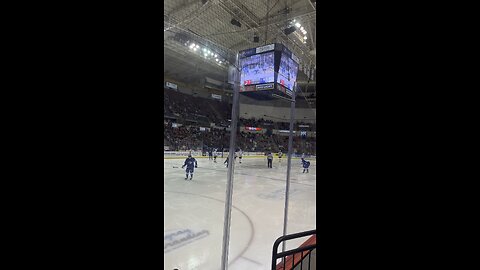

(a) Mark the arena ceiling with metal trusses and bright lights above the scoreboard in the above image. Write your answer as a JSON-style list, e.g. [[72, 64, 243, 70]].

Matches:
[[164, 0, 316, 87]]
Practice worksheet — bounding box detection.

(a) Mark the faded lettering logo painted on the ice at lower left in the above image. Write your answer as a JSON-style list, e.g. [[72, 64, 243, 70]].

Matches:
[[163, 229, 210, 253]]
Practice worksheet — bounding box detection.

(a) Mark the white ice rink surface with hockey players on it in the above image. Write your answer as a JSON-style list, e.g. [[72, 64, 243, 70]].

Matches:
[[164, 157, 316, 270]]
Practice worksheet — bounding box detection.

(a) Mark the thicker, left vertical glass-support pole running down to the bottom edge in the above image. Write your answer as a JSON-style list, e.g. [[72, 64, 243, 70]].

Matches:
[[220, 53, 240, 270]]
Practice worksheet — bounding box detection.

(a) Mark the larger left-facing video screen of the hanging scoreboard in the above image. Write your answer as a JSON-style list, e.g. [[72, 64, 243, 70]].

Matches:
[[240, 52, 275, 86]]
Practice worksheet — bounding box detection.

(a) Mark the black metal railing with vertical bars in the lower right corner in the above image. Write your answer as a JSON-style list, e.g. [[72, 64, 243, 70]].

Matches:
[[271, 230, 317, 270]]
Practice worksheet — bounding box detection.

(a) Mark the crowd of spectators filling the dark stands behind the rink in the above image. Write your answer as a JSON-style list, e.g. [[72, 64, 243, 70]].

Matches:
[[164, 90, 315, 153]]
